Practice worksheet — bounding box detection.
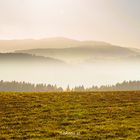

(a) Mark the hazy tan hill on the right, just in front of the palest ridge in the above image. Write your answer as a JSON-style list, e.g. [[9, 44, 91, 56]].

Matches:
[[16, 44, 140, 62]]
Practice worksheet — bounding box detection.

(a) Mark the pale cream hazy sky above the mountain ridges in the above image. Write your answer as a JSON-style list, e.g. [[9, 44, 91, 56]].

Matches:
[[0, 0, 140, 48]]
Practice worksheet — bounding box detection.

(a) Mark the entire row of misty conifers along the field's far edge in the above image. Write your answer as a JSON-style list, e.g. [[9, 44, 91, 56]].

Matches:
[[0, 80, 140, 92]]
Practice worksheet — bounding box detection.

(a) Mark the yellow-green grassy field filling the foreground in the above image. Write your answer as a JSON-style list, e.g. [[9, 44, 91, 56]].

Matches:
[[0, 91, 140, 140]]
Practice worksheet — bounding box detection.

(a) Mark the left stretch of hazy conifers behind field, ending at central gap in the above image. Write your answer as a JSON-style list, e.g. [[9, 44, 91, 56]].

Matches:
[[0, 81, 63, 92]]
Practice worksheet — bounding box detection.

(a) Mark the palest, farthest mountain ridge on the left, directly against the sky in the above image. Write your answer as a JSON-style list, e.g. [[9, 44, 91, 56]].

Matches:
[[0, 37, 119, 52]]
